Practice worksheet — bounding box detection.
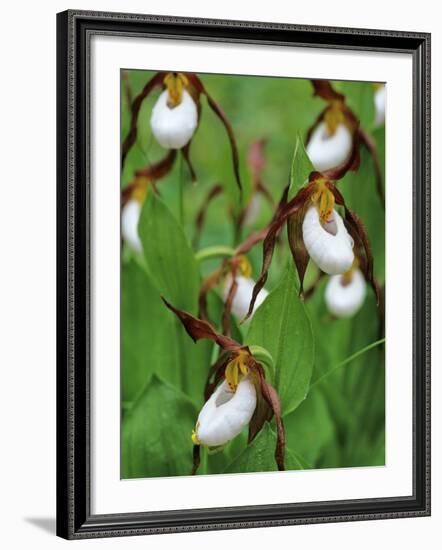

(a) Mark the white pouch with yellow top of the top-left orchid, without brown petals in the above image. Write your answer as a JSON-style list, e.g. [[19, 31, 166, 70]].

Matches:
[[150, 73, 198, 149]]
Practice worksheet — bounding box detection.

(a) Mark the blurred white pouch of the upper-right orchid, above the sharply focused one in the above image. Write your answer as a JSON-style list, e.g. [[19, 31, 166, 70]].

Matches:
[[307, 122, 353, 172]]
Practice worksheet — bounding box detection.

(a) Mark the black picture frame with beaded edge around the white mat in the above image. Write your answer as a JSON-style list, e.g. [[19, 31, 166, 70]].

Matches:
[[57, 10, 430, 539]]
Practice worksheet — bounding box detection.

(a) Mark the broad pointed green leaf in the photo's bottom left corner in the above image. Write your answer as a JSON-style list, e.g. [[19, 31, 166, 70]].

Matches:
[[121, 376, 197, 479]]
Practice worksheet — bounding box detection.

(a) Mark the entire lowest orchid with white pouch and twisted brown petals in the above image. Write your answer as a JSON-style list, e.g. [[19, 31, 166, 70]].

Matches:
[[163, 298, 285, 474]]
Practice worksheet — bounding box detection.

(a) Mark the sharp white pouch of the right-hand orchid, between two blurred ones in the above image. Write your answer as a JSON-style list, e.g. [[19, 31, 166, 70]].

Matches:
[[302, 206, 354, 275]]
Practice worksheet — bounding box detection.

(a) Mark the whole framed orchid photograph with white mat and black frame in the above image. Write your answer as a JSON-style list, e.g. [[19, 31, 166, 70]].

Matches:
[[57, 10, 430, 539]]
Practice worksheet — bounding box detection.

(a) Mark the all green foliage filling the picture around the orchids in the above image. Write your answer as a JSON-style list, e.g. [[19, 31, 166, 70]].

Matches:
[[121, 71, 385, 478]]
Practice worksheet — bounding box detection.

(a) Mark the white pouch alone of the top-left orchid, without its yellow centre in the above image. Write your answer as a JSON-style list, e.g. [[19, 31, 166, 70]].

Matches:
[[150, 90, 198, 149]]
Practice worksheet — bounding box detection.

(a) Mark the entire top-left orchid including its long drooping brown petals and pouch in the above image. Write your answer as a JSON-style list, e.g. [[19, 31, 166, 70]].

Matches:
[[121, 72, 242, 191]]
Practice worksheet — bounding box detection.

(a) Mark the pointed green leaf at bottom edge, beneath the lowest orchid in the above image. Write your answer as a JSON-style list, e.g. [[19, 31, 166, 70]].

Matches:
[[224, 422, 278, 474]]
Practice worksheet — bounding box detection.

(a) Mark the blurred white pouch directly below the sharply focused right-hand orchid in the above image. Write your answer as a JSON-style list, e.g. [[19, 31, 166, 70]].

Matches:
[[325, 269, 366, 317]]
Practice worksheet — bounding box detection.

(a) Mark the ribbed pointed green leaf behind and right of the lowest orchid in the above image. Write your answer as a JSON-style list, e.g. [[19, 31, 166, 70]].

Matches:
[[246, 262, 314, 416]]
